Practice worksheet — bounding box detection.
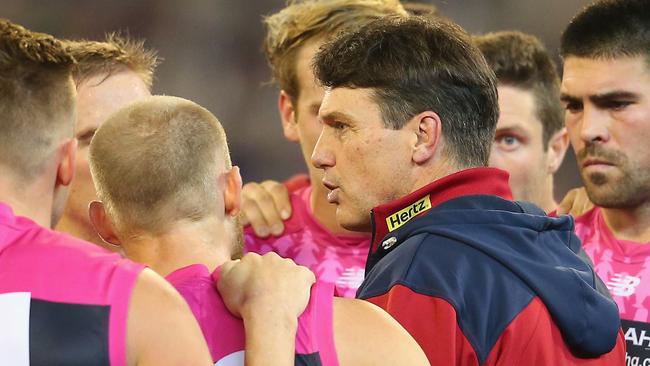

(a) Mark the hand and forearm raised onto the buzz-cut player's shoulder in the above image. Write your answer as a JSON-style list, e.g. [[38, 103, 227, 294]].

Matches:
[[217, 253, 315, 366]]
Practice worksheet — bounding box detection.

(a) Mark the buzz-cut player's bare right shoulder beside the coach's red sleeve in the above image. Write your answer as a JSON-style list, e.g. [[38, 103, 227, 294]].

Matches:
[[333, 298, 429, 366]]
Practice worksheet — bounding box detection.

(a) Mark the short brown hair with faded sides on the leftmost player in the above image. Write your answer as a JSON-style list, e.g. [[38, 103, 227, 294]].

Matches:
[[0, 19, 76, 182]]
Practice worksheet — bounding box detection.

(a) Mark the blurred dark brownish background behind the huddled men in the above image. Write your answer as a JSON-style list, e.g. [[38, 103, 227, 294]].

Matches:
[[0, 0, 590, 197]]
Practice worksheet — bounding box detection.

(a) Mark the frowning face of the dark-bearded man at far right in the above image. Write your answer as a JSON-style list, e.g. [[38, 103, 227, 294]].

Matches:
[[562, 56, 650, 208]]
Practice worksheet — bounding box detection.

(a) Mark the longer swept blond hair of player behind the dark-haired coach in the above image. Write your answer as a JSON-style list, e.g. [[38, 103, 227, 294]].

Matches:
[[264, 0, 406, 102]]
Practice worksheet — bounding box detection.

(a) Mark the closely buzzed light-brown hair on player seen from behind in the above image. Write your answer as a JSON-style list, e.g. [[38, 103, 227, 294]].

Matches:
[[89, 96, 231, 235]]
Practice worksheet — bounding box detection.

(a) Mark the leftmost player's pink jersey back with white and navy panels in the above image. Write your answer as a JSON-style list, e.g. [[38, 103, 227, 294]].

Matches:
[[0, 203, 143, 366]]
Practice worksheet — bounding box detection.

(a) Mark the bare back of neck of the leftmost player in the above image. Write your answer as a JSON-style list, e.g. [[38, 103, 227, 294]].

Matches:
[[0, 177, 54, 228]]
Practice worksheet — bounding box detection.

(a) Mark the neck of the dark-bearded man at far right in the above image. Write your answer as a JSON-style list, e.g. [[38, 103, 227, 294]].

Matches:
[[601, 203, 650, 243]]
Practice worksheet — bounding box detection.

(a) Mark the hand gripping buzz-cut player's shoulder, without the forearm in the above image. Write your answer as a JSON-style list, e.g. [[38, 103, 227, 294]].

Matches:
[[217, 252, 316, 321]]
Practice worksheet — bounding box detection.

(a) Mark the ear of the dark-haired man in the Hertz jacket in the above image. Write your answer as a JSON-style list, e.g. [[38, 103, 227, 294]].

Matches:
[[408, 111, 442, 164]]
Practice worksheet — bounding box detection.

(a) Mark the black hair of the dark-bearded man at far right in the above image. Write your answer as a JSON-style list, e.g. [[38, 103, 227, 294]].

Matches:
[[560, 0, 650, 63]]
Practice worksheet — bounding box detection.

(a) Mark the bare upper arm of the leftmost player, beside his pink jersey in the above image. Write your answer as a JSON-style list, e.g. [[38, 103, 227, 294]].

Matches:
[[127, 269, 212, 366]]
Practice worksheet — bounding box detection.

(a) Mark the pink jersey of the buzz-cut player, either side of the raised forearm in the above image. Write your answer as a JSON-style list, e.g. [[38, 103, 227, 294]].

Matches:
[[166, 264, 338, 366]]
